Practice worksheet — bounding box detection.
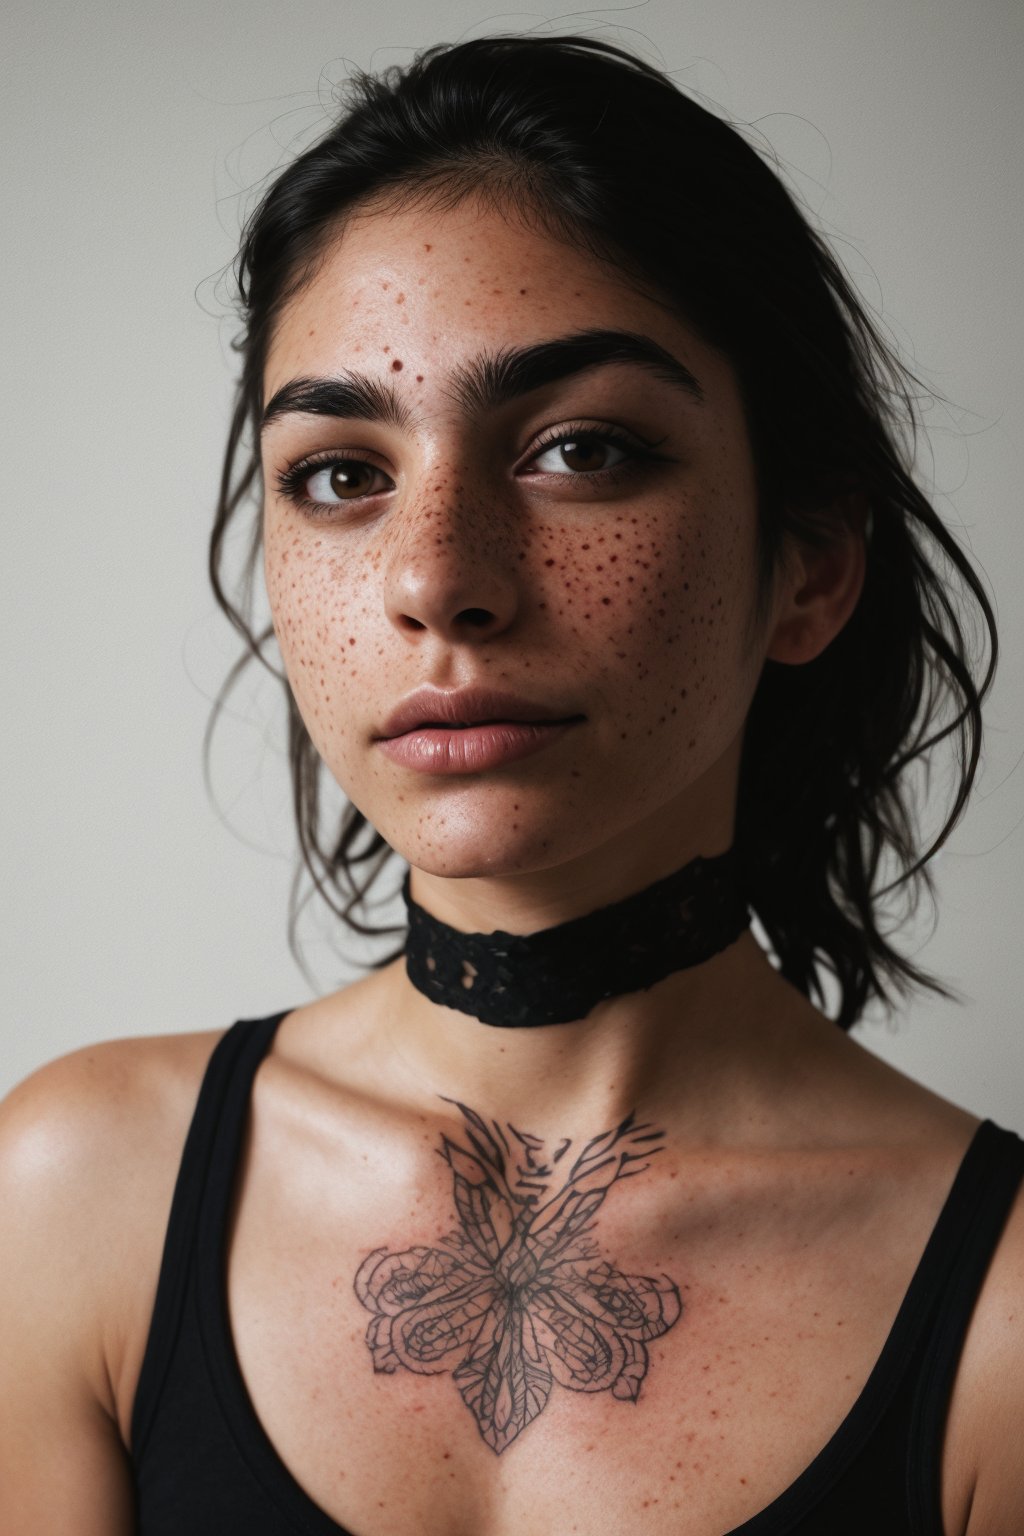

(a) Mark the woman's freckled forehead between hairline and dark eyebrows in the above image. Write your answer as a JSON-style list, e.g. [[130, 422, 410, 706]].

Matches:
[[264, 201, 724, 399]]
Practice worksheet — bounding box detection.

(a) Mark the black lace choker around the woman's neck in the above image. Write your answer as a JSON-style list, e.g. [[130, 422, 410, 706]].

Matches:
[[402, 848, 751, 1029]]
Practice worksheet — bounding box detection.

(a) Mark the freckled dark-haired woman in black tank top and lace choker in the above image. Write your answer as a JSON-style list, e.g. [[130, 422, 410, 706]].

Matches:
[[0, 29, 1024, 1536]]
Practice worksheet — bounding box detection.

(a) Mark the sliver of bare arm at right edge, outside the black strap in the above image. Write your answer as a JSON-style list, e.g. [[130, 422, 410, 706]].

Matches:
[[947, 1161, 1024, 1536]]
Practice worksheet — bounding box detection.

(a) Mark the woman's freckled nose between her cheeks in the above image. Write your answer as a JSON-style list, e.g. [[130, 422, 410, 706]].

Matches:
[[384, 488, 519, 642]]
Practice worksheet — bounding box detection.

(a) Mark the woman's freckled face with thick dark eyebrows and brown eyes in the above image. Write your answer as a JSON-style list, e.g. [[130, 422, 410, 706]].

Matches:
[[263, 203, 779, 879]]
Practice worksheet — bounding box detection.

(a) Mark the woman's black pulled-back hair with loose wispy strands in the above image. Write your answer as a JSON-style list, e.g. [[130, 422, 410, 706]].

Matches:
[[206, 37, 998, 1028]]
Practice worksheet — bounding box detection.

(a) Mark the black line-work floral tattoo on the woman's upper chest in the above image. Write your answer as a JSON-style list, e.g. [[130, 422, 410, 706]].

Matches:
[[355, 1100, 683, 1455]]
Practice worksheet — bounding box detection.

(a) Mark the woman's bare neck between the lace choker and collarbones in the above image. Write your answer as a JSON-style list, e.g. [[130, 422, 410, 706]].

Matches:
[[379, 931, 809, 1140]]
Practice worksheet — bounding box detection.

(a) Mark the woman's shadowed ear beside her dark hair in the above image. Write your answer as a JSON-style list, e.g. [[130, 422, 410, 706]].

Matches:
[[765, 496, 867, 667]]
